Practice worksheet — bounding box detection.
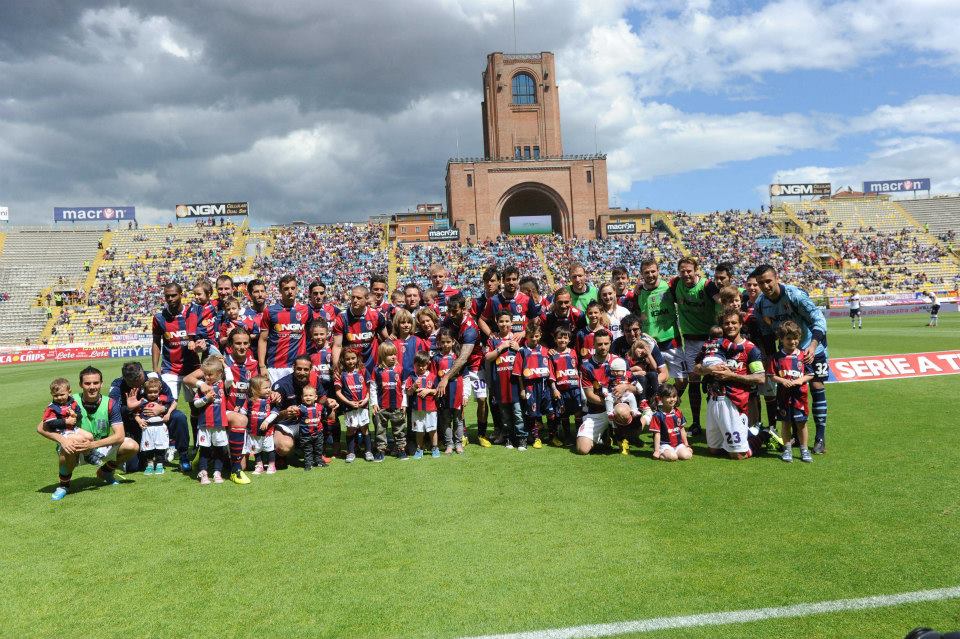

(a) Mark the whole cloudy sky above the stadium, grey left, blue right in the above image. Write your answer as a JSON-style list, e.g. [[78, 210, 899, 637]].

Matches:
[[0, 0, 960, 224]]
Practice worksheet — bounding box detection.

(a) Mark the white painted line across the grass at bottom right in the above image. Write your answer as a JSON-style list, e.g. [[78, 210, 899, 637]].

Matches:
[[465, 586, 960, 639]]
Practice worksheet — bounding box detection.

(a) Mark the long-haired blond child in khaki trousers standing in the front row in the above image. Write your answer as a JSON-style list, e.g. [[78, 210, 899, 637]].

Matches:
[[370, 342, 409, 462]]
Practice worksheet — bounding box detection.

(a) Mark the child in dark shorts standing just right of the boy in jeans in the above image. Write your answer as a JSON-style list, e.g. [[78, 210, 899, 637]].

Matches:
[[513, 323, 557, 448]]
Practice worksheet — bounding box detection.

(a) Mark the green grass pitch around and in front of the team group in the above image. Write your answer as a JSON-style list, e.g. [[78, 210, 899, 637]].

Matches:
[[0, 315, 960, 638]]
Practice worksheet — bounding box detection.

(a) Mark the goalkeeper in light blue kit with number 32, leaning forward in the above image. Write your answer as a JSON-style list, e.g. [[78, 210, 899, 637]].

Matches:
[[754, 264, 830, 455]]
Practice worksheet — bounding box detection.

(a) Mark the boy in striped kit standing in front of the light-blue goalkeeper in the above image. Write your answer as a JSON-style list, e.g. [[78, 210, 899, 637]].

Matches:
[[772, 320, 813, 464]]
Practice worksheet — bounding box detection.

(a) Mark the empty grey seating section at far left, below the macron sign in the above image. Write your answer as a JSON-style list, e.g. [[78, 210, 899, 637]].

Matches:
[[0, 226, 103, 345]]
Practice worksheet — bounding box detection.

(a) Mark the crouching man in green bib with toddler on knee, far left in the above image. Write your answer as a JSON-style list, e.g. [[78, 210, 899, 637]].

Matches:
[[37, 366, 140, 501]]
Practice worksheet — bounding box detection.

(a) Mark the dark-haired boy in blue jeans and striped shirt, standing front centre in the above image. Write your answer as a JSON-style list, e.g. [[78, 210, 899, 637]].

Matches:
[[484, 308, 527, 451]]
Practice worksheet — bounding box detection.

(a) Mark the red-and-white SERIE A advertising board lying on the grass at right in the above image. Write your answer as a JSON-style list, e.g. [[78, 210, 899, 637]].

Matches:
[[828, 351, 960, 382]]
